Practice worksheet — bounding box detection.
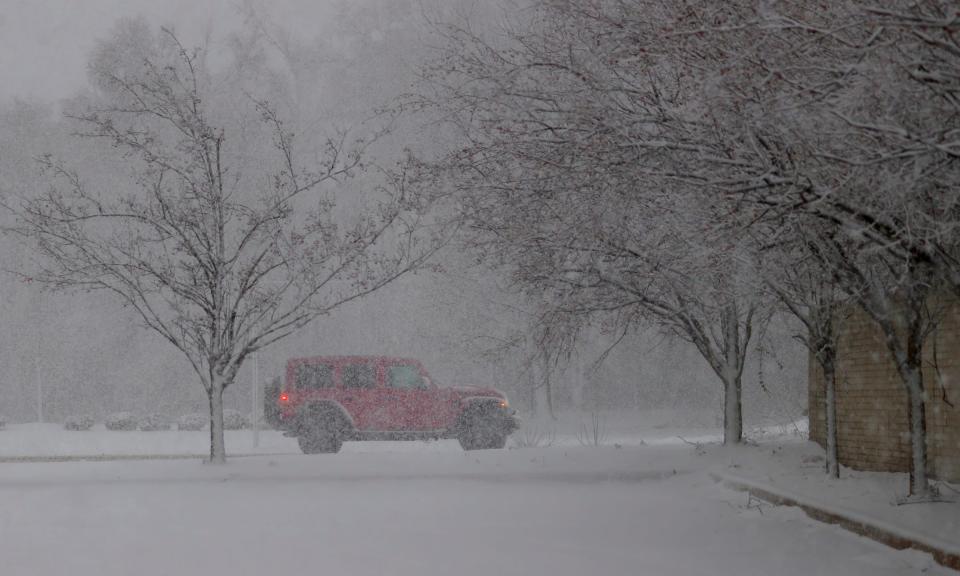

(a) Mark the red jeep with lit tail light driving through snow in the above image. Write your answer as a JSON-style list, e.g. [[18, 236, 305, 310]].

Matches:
[[277, 356, 518, 454]]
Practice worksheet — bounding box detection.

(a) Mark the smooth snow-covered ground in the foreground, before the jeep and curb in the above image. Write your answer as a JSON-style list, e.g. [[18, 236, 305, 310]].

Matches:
[[0, 430, 955, 576]]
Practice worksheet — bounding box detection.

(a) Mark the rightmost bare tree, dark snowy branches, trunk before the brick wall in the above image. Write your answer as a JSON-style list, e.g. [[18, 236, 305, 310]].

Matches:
[[704, 0, 960, 497]]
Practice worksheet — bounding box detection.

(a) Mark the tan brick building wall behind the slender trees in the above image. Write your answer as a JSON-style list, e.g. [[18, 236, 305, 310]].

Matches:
[[809, 304, 960, 481]]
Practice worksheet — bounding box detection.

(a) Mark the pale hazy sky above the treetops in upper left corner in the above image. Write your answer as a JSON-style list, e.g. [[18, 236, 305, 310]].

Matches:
[[0, 0, 344, 101]]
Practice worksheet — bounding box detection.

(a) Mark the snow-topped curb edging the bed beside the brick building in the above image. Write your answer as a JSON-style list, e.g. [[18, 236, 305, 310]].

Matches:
[[710, 472, 960, 570]]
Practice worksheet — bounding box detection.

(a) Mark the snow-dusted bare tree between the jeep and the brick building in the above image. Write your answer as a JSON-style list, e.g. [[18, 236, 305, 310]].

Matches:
[[410, 1, 766, 443]]
